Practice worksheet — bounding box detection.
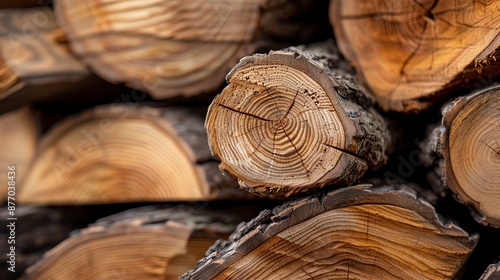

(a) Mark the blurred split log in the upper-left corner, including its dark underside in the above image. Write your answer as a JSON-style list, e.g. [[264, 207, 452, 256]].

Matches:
[[0, 7, 124, 113]]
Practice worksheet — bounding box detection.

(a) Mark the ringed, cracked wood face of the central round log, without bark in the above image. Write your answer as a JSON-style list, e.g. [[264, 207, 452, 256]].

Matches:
[[207, 61, 345, 194]]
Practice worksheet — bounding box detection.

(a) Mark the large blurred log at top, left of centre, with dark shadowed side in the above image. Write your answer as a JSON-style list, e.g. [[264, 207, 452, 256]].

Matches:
[[55, 0, 328, 99]]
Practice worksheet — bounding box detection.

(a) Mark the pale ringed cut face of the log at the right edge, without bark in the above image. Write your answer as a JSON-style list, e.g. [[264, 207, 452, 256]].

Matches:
[[449, 90, 500, 224]]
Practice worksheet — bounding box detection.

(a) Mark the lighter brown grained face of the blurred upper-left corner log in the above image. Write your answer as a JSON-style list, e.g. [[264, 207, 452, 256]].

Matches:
[[0, 7, 89, 97]]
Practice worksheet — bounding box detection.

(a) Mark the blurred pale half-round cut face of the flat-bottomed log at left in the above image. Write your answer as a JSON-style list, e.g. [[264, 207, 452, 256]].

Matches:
[[19, 109, 208, 204]]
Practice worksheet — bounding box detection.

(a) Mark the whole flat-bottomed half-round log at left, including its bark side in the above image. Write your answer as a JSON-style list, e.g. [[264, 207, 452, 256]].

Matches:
[[17, 103, 251, 205]]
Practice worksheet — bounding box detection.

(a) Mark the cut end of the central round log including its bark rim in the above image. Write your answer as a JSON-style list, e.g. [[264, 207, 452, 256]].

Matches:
[[205, 51, 366, 198]]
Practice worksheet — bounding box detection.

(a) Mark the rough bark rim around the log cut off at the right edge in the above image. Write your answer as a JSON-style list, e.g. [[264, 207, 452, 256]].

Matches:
[[428, 85, 500, 227]]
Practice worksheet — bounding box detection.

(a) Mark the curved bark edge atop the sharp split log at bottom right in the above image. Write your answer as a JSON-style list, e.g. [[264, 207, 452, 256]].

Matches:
[[179, 184, 479, 280]]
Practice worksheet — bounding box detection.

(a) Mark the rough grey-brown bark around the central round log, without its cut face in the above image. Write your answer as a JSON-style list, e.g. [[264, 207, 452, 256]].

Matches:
[[209, 40, 392, 198]]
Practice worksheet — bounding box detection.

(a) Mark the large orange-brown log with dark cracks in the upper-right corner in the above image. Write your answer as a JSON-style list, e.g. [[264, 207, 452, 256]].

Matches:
[[330, 0, 500, 112]]
